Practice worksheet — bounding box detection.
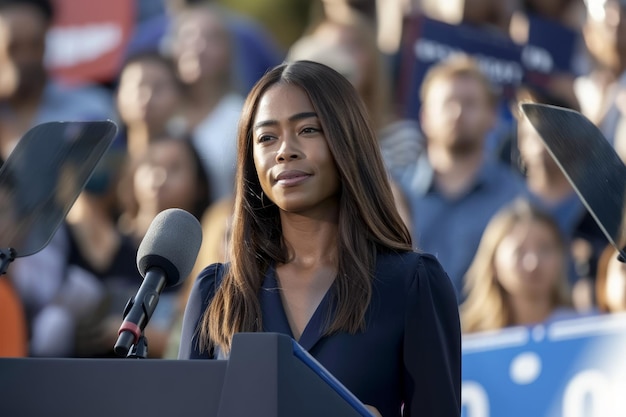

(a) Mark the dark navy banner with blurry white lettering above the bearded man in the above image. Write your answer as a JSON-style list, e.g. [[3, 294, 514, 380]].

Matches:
[[397, 15, 578, 119]]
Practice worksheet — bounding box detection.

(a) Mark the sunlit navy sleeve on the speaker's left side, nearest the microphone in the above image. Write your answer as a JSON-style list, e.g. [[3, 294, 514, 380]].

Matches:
[[178, 263, 224, 359]]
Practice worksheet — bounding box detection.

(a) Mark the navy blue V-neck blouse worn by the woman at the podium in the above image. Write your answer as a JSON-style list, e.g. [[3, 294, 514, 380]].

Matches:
[[179, 252, 461, 417]]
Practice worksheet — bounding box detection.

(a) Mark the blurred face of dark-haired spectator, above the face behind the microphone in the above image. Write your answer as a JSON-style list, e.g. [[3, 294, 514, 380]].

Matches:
[[117, 61, 181, 130]]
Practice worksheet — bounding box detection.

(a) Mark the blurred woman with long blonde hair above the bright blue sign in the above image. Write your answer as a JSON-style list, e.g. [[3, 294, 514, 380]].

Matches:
[[461, 199, 573, 333]]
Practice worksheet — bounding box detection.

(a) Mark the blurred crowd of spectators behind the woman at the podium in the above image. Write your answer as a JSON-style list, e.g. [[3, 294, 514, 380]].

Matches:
[[0, 0, 626, 358]]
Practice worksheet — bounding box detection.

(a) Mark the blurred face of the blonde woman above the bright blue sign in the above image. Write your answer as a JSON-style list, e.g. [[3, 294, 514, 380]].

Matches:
[[494, 220, 565, 299]]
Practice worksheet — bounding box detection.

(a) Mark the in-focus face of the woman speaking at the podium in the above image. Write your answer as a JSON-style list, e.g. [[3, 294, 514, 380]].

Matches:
[[252, 84, 340, 216]]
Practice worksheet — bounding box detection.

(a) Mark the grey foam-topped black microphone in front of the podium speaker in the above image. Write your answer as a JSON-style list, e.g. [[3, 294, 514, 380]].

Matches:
[[113, 209, 202, 356]]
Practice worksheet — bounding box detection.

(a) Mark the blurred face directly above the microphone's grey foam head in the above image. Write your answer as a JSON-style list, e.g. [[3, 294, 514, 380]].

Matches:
[[134, 140, 201, 213]]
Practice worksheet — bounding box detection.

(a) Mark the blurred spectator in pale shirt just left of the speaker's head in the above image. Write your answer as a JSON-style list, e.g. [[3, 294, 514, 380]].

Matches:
[[170, 4, 243, 200]]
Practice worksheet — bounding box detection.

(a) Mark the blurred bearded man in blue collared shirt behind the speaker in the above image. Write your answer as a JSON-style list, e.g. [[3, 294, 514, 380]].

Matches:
[[397, 56, 525, 302]]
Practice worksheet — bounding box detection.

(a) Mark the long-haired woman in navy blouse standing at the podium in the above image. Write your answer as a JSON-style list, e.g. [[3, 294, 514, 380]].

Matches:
[[179, 61, 461, 416]]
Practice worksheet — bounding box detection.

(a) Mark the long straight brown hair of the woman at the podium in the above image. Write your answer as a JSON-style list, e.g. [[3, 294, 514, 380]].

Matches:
[[200, 61, 412, 352]]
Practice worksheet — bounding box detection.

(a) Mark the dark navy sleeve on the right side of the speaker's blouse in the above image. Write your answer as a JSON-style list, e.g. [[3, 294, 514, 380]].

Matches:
[[404, 254, 461, 417]]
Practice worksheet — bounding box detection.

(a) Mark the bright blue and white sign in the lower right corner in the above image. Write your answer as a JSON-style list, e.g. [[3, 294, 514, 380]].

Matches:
[[462, 314, 626, 417]]
